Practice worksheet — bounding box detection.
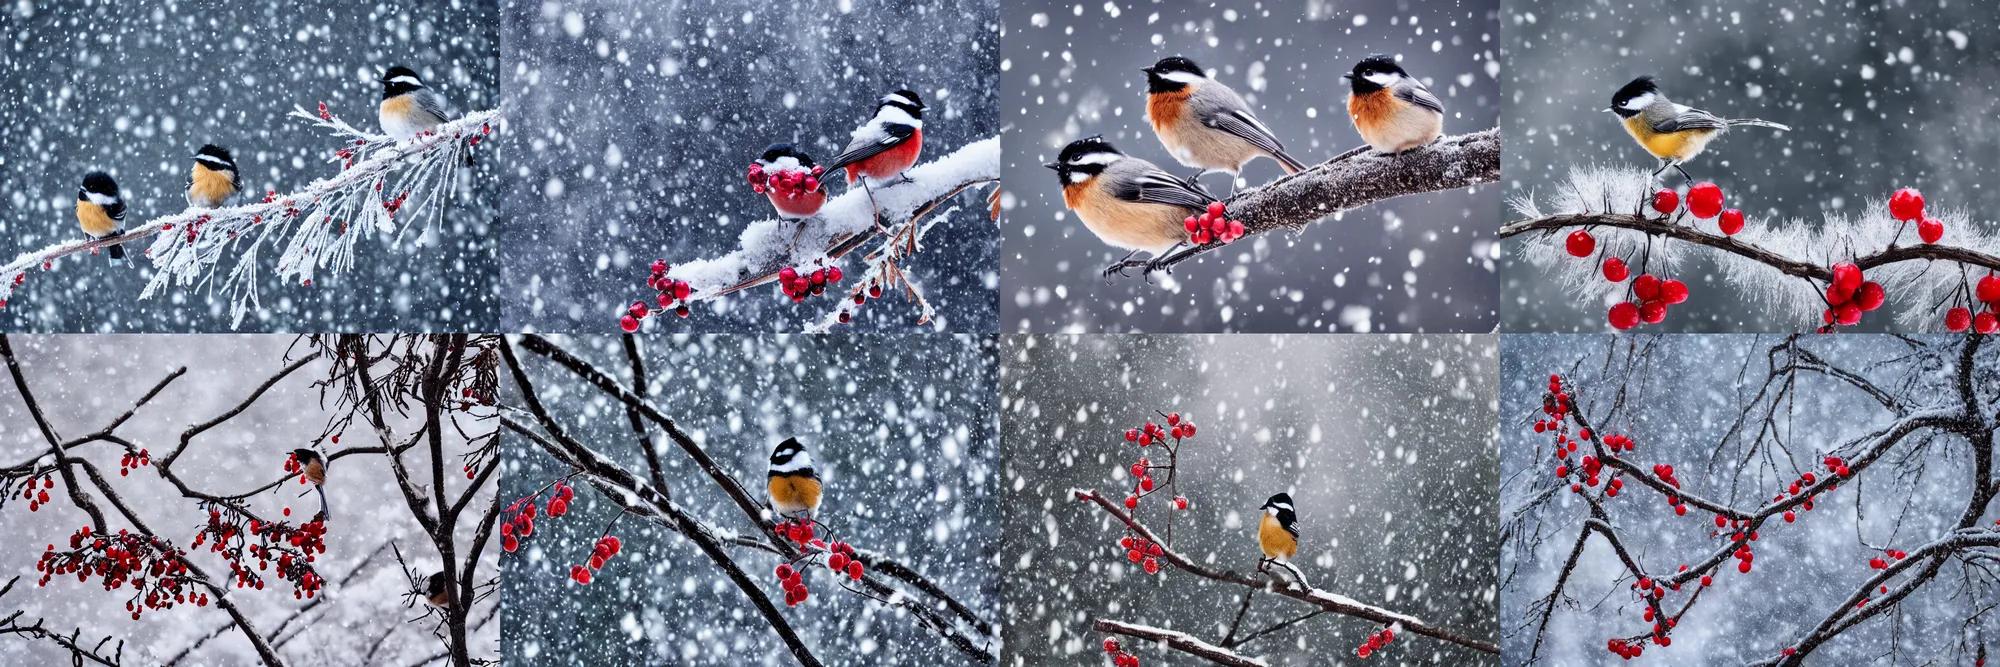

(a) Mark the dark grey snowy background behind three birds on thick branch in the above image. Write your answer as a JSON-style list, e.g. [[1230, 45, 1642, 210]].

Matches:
[[1000, 0, 1512, 334]]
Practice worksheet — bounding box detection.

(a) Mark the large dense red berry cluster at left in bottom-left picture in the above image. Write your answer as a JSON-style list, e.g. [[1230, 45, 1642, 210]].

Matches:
[[34, 525, 208, 621]]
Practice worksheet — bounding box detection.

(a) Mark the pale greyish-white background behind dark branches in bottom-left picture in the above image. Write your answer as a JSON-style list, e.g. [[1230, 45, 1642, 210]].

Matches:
[[0, 334, 500, 665]]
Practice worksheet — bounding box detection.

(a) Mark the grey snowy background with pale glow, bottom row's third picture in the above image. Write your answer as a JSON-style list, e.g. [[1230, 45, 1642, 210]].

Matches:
[[1000, 335, 1498, 665]]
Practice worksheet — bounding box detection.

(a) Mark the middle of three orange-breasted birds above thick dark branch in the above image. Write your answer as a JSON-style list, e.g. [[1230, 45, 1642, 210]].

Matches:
[[1140, 56, 1306, 186]]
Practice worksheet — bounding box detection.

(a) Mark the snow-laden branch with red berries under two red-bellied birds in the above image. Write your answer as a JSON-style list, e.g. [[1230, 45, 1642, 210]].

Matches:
[[622, 138, 1000, 332]]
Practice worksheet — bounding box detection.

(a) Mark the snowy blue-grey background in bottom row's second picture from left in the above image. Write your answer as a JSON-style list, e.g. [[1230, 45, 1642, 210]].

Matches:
[[502, 335, 1002, 665]]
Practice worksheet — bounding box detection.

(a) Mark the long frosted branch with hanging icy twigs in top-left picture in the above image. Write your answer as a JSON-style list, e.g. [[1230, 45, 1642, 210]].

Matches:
[[0, 104, 500, 326]]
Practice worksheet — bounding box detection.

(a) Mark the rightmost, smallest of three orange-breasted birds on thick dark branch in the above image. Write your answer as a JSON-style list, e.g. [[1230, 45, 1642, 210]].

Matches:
[[1342, 56, 1444, 154]]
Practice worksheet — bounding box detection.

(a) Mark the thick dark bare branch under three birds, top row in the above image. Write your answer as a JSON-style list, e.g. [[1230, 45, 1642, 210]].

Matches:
[[1128, 128, 1500, 275]]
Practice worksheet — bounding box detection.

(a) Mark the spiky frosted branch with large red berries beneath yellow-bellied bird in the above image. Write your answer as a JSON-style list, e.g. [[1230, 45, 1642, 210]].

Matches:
[[1500, 166, 2000, 332]]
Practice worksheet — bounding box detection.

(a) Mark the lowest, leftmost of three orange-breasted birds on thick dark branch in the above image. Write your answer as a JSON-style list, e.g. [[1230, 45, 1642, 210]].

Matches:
[[1044, 136, 1216, 276]]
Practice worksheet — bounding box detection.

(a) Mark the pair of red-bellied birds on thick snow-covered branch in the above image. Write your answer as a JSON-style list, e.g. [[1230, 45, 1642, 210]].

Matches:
[[754, 90, 924, 220]]
